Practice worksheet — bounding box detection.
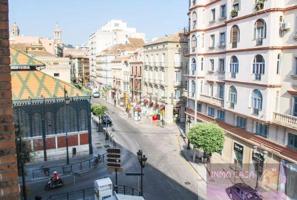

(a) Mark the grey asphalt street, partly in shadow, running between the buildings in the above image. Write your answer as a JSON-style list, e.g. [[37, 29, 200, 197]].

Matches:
[[29, 99, 201, 200]]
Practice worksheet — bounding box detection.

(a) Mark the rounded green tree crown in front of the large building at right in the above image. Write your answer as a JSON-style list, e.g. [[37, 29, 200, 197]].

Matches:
[[189, 123, 224, 155]]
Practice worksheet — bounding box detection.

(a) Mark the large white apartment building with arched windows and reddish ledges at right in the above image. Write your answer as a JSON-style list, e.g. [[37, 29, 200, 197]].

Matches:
[[186, 0, 297, 199]]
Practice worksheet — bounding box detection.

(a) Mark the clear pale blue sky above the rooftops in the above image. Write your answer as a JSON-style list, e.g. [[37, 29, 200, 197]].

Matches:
[[9, 0, 188, 45]]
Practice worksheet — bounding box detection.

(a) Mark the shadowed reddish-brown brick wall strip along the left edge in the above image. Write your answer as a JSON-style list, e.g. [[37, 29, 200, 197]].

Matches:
[[0, 0, 19, 200]]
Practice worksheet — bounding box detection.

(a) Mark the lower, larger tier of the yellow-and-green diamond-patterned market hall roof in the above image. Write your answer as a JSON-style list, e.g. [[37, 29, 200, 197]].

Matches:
[[11, 70, 88, 100]]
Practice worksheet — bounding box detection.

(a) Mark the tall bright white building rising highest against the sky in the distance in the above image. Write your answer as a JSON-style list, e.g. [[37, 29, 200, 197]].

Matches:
[[88, 20, 145, 85]]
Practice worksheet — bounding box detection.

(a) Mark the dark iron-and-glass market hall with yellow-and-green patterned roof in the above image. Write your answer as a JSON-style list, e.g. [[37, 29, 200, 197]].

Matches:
[[10, 49, 92, 159]]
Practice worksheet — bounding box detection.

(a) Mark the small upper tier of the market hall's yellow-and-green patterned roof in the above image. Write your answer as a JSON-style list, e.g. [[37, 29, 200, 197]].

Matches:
[[10, 48, 45, 67]]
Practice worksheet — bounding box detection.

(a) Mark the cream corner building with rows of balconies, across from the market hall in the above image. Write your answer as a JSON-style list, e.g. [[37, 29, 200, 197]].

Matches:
[[141, 33, 187, 123]]
